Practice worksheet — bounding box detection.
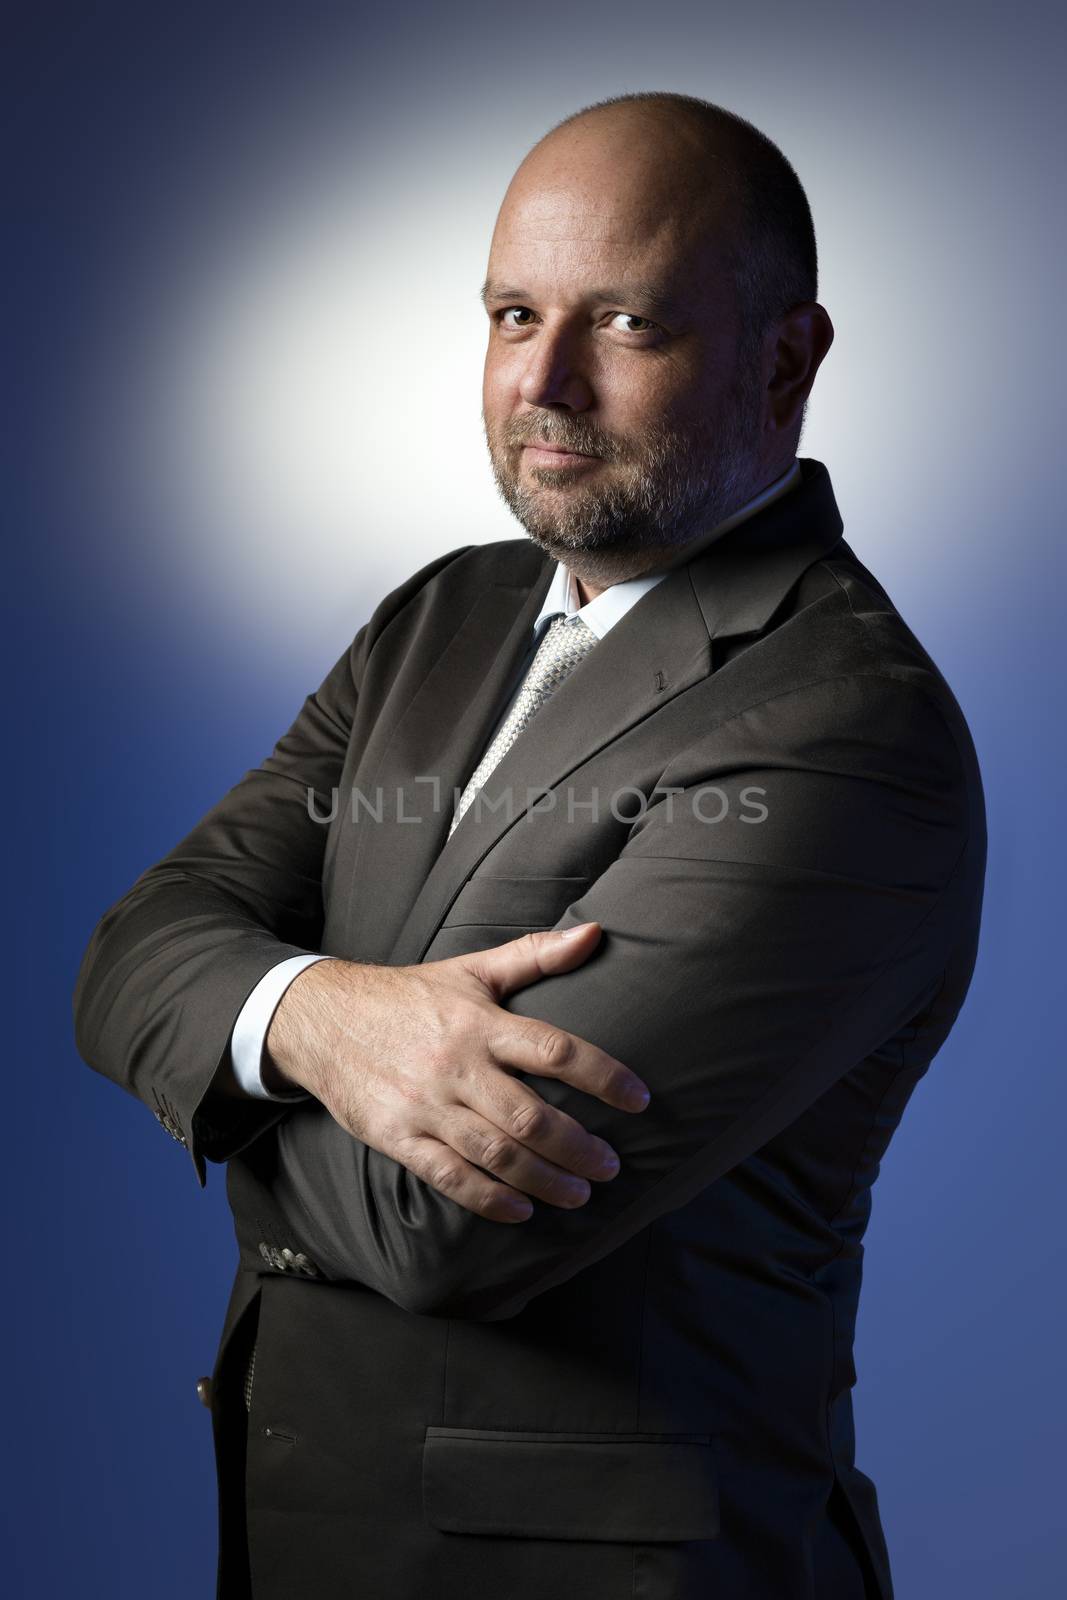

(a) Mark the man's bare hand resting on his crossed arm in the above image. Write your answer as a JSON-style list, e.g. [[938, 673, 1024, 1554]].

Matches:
[[264, 922, 646, 1222]]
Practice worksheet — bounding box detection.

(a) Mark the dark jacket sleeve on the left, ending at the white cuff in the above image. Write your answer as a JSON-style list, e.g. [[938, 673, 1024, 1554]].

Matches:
[[74, 546, 470, 1187]]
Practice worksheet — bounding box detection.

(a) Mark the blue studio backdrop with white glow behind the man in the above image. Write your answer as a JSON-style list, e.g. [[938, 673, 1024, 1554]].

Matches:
[[0, 0, 1067, 1600]]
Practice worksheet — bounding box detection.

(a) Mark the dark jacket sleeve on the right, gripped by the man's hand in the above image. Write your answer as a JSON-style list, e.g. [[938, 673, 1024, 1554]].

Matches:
[[227, 675, 984, 1320]]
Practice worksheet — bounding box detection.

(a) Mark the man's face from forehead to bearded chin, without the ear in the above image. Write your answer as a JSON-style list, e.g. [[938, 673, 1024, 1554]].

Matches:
[[482, 118, 765, 581]]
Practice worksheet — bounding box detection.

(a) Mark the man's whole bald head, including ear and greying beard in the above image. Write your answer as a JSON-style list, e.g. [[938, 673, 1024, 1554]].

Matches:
[[483, 94, 832, 584]]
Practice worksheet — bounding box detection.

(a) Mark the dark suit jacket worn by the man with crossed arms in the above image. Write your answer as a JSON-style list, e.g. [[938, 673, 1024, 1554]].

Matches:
[[75, 459, 985, 1600]]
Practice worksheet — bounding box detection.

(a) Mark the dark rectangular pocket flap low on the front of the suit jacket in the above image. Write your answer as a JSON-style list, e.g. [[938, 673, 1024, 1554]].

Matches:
[[422, 1427, 718, 1542]]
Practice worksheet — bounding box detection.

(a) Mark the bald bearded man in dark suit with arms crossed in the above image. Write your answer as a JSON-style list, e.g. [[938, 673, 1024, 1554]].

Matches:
[[75, 93, 985, 1600]]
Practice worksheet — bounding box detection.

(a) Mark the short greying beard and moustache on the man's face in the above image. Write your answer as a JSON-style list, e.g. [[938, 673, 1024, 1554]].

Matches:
[[482, 352, 763, 582]]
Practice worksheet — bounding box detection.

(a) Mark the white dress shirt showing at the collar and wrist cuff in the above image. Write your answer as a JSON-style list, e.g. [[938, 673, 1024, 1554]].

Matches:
[[230, 461, 800, 1101]]
